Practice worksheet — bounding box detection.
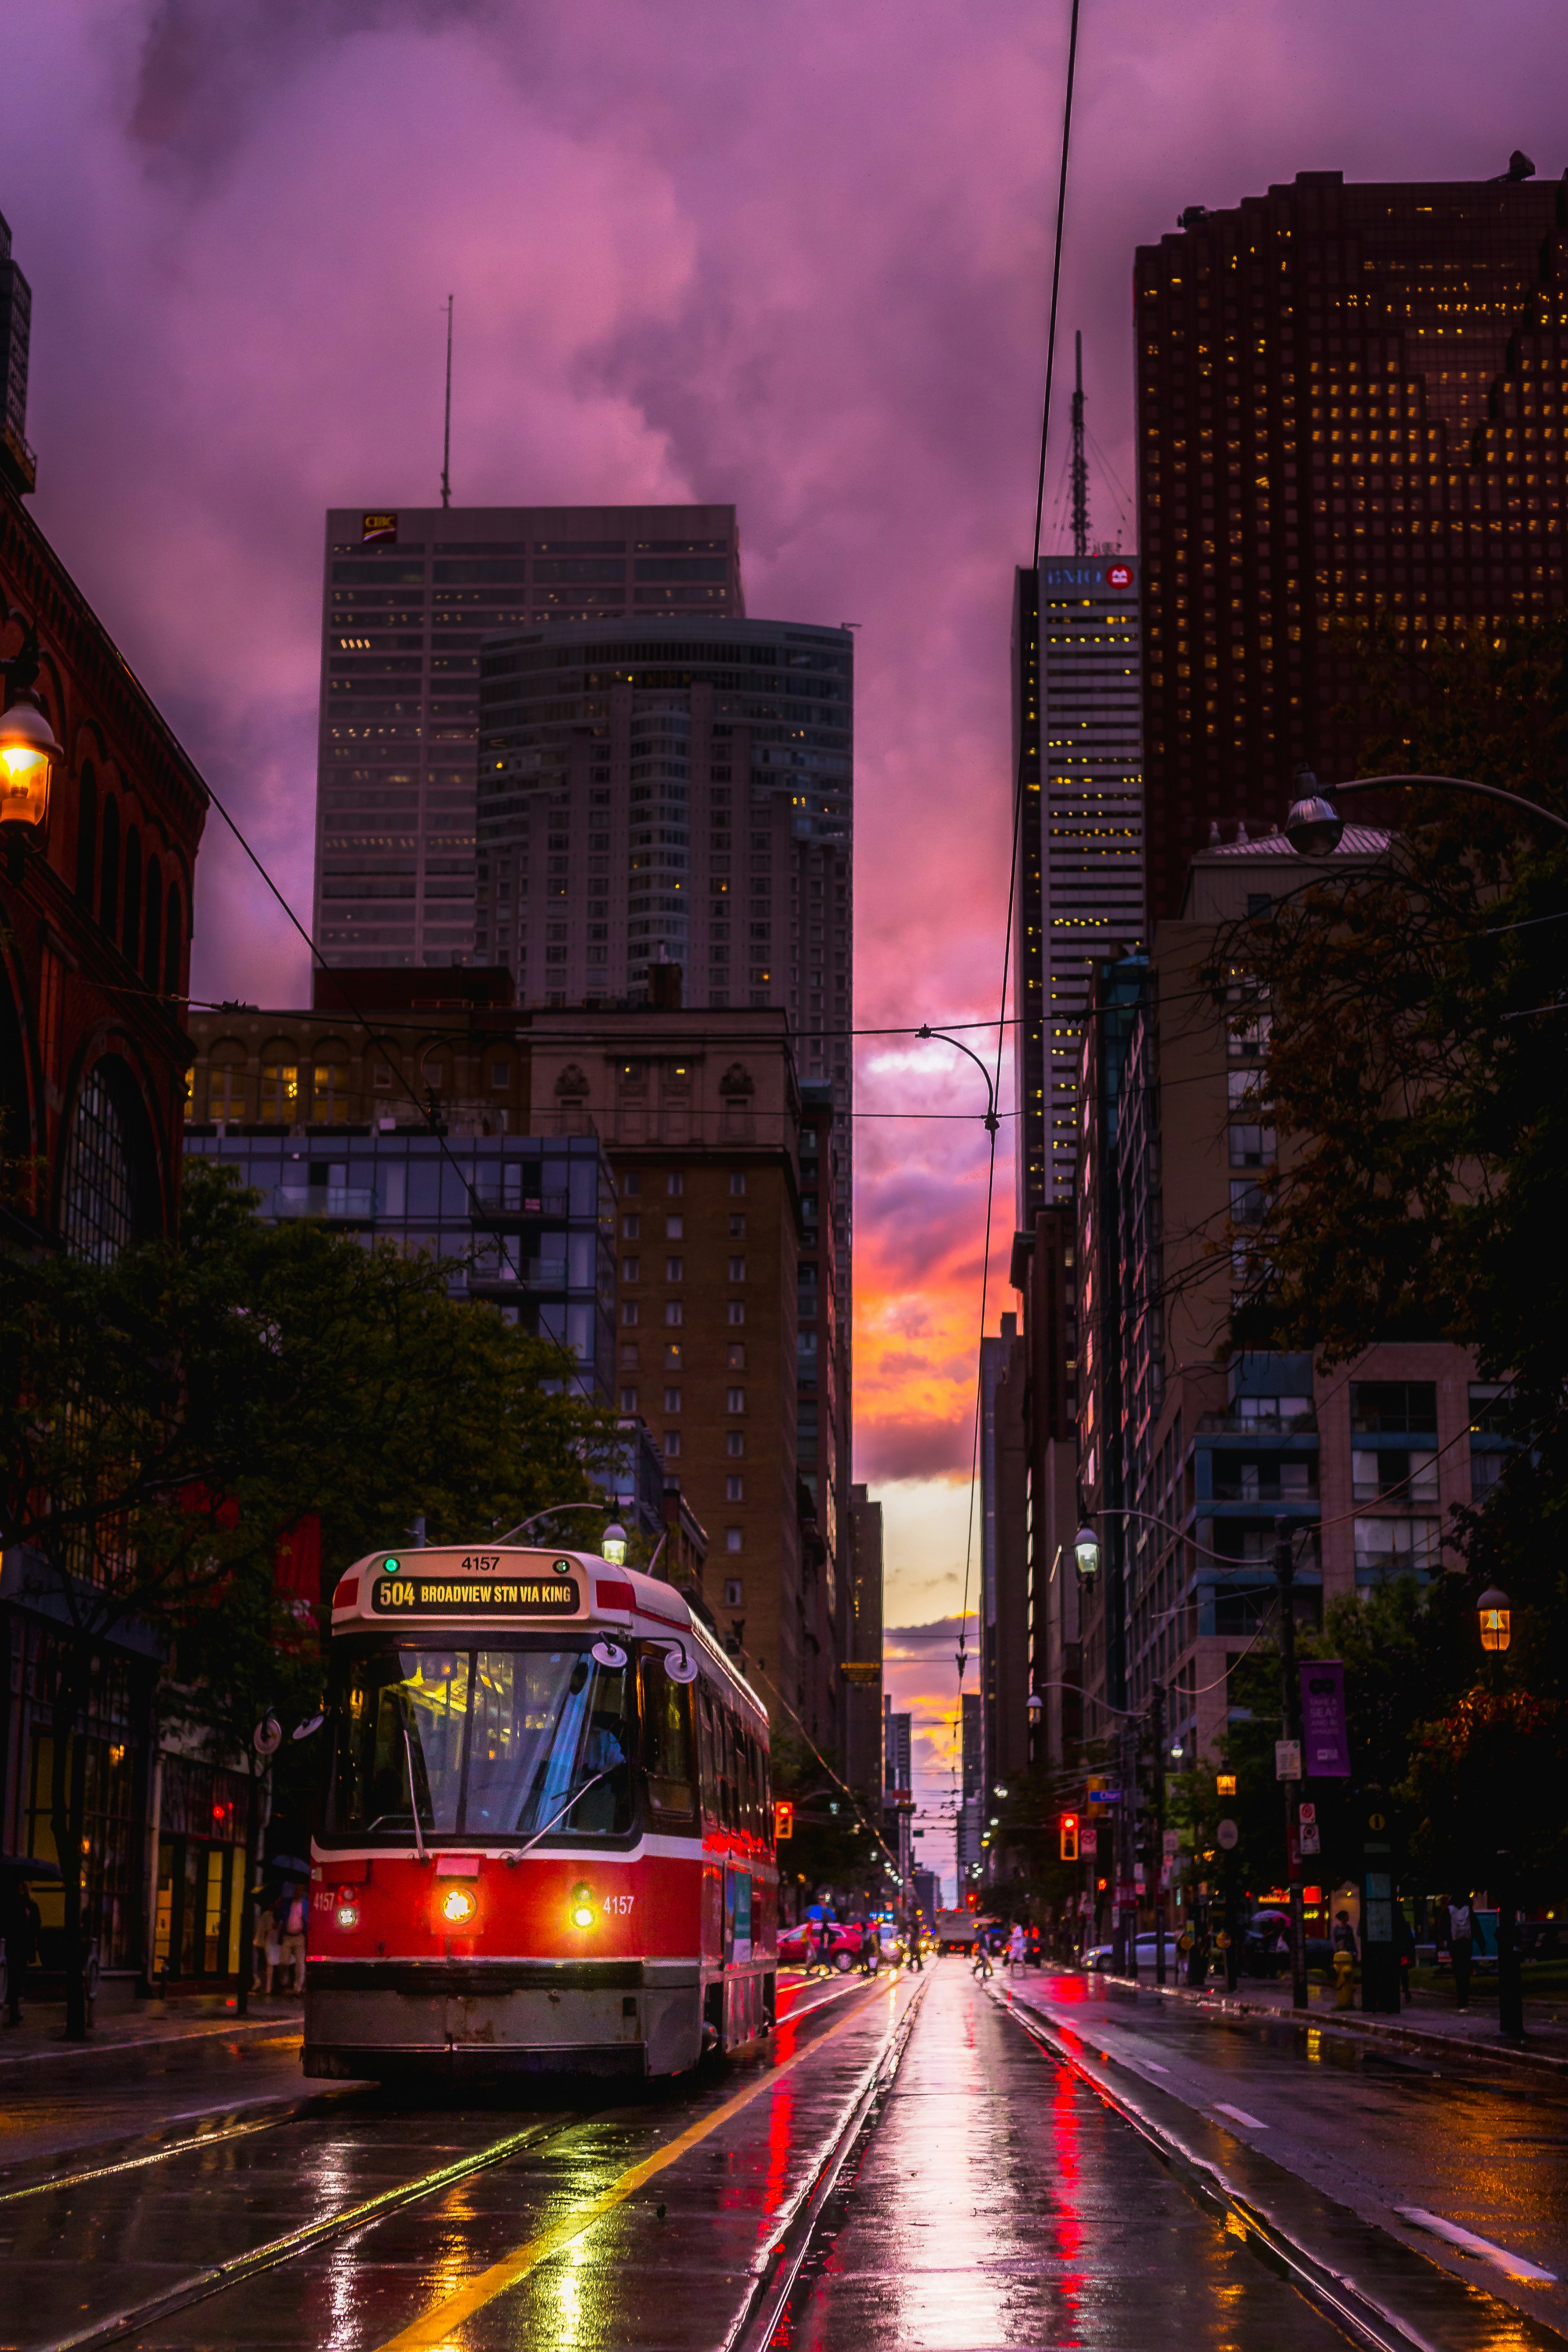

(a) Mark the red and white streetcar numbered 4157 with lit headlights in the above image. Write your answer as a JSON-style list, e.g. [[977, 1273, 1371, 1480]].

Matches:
[[305, 1548, 778, 2077]]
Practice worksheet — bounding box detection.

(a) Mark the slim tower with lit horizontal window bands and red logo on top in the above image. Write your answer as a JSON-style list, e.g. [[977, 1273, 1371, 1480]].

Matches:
[[1013, 550, 1142, 1230]]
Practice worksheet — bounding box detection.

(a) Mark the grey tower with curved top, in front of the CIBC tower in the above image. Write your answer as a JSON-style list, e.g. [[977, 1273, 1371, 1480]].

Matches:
[[475, 616, 853, 1301]]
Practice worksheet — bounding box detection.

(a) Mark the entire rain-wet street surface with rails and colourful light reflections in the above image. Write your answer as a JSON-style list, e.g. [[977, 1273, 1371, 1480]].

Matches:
[[0, 1961, 1568, 2352]]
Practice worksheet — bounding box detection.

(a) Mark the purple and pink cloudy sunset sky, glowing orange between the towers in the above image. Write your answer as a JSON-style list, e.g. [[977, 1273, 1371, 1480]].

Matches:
[[0, 0, 1568, 1768]]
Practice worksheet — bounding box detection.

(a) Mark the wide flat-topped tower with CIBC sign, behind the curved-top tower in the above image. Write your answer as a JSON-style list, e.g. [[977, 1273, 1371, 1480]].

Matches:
[[315, 506, 745, 967]]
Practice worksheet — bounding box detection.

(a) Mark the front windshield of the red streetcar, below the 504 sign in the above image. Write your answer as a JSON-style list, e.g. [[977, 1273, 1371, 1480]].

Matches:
[[327, 1644, 632, 1842]]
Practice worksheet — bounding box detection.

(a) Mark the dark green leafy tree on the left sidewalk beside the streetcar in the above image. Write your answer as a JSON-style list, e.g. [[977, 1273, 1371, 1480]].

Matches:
[[0, 1162, 614, 2034]]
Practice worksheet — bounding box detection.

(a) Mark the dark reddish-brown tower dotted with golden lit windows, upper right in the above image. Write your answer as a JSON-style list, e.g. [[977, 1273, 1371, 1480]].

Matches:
[[1135, 155, 1568, 920]]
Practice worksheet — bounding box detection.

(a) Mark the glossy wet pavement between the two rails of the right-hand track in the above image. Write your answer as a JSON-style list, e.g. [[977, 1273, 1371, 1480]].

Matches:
[[776, 1961, 1344, 2352]]
